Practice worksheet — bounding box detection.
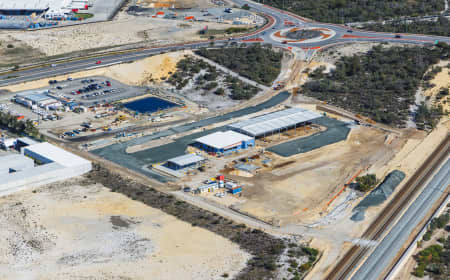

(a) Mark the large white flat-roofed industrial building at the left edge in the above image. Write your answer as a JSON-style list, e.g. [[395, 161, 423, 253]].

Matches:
[[0, 142, 92, 196]]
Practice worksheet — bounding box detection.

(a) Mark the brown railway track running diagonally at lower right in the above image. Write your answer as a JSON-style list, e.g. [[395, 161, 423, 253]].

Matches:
[[325, 136, 450, 280]]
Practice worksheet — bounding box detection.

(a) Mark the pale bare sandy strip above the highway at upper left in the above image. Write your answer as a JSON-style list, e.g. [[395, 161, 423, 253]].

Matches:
[[0, 12, 248, 56]]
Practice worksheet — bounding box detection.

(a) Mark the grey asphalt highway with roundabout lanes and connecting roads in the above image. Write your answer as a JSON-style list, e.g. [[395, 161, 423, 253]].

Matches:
[[0, 0, 450, 86]]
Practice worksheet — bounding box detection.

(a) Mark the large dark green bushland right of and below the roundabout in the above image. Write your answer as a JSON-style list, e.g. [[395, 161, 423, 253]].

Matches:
[[303, 43, 450, 127]]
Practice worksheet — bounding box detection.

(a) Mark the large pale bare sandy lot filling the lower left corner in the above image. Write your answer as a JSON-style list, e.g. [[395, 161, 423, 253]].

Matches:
[[0, 179, 250, 279]]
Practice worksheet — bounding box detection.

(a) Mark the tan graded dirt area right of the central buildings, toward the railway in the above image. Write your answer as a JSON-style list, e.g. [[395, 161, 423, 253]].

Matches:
[[232, 124, 395, 224]]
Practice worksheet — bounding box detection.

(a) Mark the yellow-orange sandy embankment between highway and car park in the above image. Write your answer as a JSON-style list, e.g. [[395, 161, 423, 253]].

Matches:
[[0, 51, 186, 92]]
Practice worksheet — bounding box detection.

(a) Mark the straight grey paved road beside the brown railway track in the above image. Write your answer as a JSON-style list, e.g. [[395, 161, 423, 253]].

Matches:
[[352, 160, 450, 280]]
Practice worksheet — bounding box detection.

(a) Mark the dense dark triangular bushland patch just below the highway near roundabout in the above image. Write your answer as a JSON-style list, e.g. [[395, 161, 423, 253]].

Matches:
[[195, 44, 283, 86]]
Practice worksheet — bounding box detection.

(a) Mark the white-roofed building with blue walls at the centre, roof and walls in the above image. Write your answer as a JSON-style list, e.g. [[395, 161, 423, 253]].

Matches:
[[194, 130, 255, 154]]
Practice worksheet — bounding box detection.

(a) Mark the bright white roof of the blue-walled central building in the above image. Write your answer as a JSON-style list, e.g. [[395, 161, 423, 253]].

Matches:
[[195, 130, 253, 149]]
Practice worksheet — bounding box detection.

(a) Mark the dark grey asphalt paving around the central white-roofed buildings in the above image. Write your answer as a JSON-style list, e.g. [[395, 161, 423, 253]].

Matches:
[[91, 91, 356, 182]]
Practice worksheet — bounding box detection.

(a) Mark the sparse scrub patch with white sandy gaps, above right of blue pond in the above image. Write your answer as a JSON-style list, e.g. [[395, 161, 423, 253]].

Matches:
[[167, 56, 259, 100]]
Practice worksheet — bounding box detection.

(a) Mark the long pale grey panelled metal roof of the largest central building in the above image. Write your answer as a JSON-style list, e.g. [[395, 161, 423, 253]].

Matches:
[[228, 108, 321, 136]]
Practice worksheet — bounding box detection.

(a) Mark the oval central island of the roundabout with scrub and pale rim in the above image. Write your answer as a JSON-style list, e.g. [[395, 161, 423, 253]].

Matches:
[[270, 27, 336, 44]]
